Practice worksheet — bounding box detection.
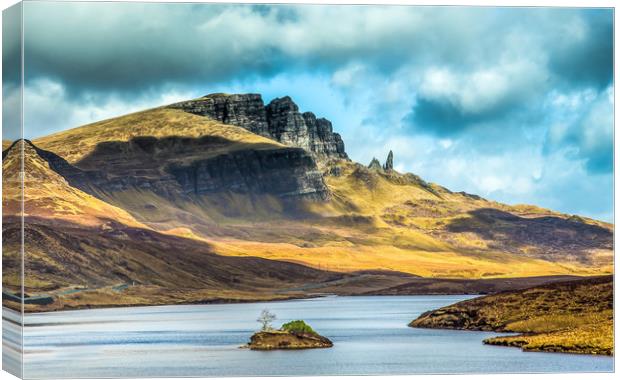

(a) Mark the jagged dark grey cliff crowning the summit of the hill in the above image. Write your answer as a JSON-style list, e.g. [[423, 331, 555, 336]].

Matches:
[[169, 94, 348, 163]]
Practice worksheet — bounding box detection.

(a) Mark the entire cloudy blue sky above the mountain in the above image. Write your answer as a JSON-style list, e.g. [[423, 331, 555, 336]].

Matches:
[[3, 2, 614, 221]]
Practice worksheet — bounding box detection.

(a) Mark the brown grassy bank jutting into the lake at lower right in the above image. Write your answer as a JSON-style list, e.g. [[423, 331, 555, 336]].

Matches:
[[410, 276, 613, 355]]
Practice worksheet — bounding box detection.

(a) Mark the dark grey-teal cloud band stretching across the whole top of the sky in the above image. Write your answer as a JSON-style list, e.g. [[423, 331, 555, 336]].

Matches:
[[20, 2, 613, 98]]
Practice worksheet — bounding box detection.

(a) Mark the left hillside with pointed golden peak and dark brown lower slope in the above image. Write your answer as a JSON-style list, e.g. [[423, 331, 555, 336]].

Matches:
[[3, 141, 342, 310]]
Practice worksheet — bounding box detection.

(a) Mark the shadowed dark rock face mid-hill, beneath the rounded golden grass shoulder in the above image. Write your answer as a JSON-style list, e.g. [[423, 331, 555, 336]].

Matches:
[[30, 136, 329, 200]]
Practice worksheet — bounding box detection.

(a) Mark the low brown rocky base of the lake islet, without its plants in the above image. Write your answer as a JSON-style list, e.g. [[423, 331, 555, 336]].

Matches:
[[247, 330, 334, 350]]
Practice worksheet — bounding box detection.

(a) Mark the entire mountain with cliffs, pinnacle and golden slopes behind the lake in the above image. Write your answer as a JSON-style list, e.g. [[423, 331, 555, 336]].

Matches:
[[3, 94, 613, 307]]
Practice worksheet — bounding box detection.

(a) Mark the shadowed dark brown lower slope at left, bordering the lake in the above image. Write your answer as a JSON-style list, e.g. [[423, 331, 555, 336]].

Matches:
[[3, 218, 343, 311]]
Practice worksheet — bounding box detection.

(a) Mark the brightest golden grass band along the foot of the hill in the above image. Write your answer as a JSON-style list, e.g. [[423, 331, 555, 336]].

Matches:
[[210, 239, 601, 278]]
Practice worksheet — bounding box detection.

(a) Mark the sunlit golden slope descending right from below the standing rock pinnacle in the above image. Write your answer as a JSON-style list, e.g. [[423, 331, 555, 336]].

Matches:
[[207, 162, 612, 278]]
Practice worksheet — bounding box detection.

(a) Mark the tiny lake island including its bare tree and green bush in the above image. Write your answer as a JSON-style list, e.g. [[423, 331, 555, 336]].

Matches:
[[246, 310, 334, 350]]
